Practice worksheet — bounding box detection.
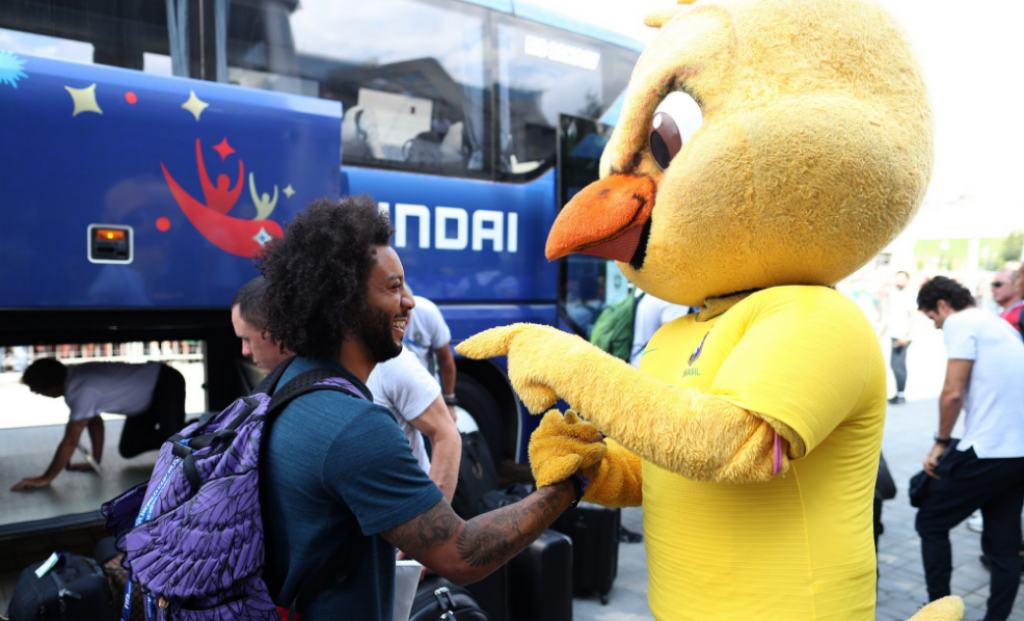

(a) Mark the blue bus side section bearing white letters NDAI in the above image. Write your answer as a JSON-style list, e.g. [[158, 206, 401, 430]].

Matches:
[[345, 167, 558, 309]]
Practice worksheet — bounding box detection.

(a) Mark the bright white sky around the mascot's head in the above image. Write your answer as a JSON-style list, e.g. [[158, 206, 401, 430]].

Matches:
[[545, 0, 1024, 239]]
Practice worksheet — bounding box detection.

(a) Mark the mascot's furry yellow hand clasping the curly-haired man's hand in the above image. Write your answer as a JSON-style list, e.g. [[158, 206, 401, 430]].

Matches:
[[529, 410, 607, 488]]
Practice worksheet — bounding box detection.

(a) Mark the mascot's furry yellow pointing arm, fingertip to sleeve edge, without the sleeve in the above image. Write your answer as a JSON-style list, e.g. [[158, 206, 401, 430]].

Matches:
[[457, 324, 802, 489]]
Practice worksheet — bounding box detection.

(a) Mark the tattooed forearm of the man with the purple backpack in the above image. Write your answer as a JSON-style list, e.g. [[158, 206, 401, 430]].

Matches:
[[456, 484, 574, 567]]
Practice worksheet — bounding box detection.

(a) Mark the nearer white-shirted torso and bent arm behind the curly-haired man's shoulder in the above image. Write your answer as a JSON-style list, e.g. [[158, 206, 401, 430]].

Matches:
[[367, 348, 462, 502]]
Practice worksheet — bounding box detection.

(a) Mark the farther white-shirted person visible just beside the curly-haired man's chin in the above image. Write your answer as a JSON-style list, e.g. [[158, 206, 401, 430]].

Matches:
[[401, 285, 459, 420]]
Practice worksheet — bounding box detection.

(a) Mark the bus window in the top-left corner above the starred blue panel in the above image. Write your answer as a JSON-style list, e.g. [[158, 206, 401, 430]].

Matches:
[[0, 0, 170, 74]]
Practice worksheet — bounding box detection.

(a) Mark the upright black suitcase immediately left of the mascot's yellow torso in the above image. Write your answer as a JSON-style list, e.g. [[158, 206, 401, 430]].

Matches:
[[551, 502, 622, 604]]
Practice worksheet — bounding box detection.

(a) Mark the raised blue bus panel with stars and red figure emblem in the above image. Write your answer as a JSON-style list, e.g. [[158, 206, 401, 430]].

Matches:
[[0, 56, 341, 308]]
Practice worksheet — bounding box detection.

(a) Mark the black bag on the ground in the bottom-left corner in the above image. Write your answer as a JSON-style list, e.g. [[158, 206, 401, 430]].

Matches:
[[7, 552, 113, 621]]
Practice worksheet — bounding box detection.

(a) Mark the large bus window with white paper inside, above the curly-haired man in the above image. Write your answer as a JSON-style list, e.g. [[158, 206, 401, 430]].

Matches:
[[227, 0, 490, 176]]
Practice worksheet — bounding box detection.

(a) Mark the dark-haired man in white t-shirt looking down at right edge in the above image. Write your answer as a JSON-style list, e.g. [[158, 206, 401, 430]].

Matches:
[[916, 277, 1024, 621]]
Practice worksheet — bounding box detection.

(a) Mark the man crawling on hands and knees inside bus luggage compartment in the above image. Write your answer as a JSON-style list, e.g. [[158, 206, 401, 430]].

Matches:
[[11, 358, 185, 491]]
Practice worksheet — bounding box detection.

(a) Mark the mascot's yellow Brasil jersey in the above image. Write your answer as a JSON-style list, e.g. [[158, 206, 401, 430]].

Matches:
[[640, 287, 886, 621]]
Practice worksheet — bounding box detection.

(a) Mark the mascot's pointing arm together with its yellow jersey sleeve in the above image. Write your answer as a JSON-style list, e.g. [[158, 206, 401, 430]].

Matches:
[[457, 287, 873, 483]]
